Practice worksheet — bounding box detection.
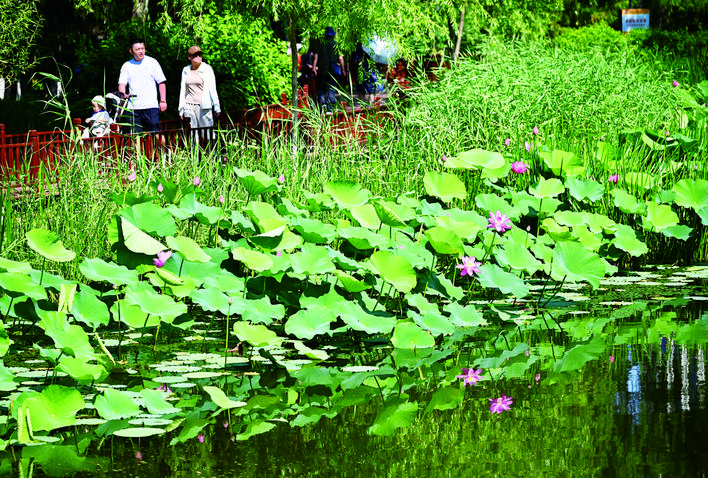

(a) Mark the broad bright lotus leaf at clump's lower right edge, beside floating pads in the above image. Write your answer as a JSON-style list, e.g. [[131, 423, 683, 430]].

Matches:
[[551, 241, 607, 288]]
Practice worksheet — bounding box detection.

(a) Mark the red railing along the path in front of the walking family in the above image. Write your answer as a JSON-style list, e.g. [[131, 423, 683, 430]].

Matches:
[[0, 86, 390, 186]]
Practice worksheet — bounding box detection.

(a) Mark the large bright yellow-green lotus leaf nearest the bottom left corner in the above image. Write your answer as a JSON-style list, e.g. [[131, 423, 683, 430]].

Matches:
[[22, 385, 86, 431]]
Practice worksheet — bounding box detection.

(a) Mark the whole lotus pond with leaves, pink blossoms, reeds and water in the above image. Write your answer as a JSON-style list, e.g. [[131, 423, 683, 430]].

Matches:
[[0, 40, 708, 477]]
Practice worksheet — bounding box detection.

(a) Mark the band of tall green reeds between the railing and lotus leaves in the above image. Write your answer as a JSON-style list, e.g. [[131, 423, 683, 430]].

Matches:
[[0, 41, 706, 278]]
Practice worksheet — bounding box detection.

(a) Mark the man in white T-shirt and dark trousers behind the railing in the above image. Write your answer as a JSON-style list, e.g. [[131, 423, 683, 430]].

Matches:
[[118, 40, 167, 133]]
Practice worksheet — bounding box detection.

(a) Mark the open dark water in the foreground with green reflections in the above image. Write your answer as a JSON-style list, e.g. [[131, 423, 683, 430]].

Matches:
[[5, 339, 708, 477]]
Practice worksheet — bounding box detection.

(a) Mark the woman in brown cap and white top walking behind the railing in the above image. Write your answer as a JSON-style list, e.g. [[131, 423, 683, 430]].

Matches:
[[179, 46, 221, 128]]
